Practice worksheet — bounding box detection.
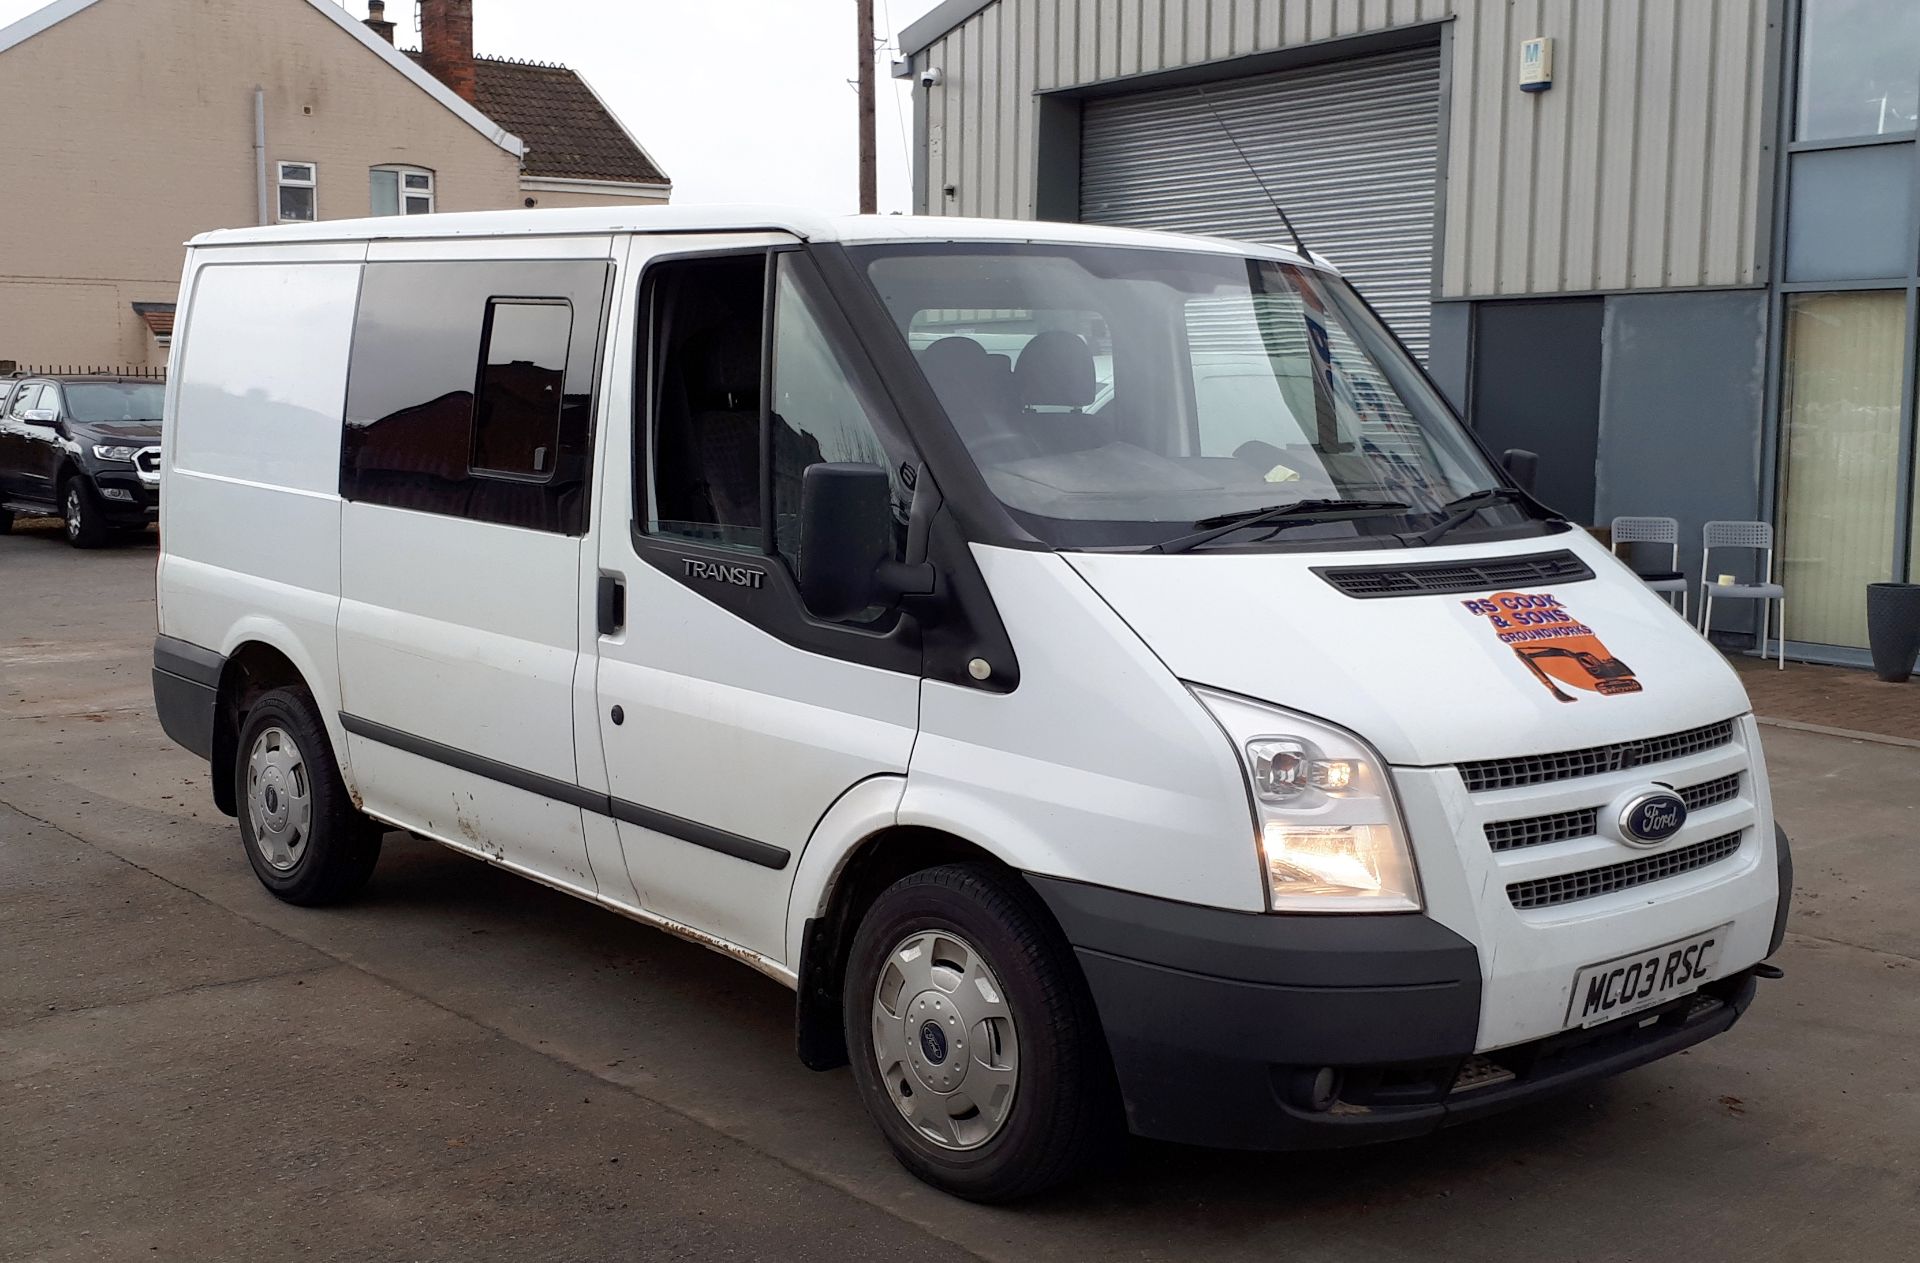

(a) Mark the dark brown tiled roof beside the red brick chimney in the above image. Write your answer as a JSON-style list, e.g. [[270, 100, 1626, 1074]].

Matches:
[[405, 48, 668, 184]]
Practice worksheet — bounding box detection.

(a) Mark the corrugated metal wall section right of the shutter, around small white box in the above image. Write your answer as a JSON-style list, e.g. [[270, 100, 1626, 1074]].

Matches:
[[1440, 0, 1770, 296]]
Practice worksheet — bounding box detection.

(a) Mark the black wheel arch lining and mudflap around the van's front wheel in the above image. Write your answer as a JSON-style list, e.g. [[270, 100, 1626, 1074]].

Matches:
[[795, 825, 1079, 1069]]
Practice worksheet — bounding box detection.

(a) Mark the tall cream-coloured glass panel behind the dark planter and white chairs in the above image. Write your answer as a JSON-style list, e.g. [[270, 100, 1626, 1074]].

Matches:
[[1766, 290, 1907, 647]]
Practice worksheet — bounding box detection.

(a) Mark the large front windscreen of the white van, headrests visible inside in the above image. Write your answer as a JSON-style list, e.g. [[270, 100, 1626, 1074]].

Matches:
[[854, 244, 1530, 547]]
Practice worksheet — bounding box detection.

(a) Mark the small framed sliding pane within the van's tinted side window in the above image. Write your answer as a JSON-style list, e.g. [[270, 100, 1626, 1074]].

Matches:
[[470, 298, 574, 482]]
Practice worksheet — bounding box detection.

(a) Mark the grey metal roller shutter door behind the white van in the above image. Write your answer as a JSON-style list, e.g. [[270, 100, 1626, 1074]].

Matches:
[[1081, 46, 1440, 359]]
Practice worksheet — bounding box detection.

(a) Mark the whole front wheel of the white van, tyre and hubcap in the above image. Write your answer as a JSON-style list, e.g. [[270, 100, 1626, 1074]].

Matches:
[[843, 864, 1116, 1202]]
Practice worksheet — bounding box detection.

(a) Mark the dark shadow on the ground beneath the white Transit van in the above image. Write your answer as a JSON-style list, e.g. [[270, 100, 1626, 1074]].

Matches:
[[348, 833, 1663, 1236]]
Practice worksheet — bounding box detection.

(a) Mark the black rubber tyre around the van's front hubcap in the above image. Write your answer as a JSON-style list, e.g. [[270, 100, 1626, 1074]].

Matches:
[[843, 864, 1119, 1202]]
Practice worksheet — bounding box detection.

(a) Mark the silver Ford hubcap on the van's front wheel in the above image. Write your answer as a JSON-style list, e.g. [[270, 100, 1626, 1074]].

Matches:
[[874, 931, 1020, 1150]]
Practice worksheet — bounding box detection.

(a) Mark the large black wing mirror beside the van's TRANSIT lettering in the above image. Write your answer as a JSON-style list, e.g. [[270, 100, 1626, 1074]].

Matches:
[[799, 463, 933, 620]]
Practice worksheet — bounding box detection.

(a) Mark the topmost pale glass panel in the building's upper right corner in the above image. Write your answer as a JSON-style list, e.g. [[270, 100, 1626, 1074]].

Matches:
[[1793, 0, 1920, 140]]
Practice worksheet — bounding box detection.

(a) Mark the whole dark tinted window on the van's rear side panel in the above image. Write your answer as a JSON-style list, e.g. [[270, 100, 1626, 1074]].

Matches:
[[340, 259, 611, 536]]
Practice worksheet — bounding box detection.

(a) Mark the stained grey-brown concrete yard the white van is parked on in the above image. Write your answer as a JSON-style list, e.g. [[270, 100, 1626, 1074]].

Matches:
[[0, 518, 1920, 1263]]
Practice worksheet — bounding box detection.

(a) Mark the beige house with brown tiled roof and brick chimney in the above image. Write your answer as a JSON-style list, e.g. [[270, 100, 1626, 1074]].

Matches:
[[0, 0, 672, 367]]
